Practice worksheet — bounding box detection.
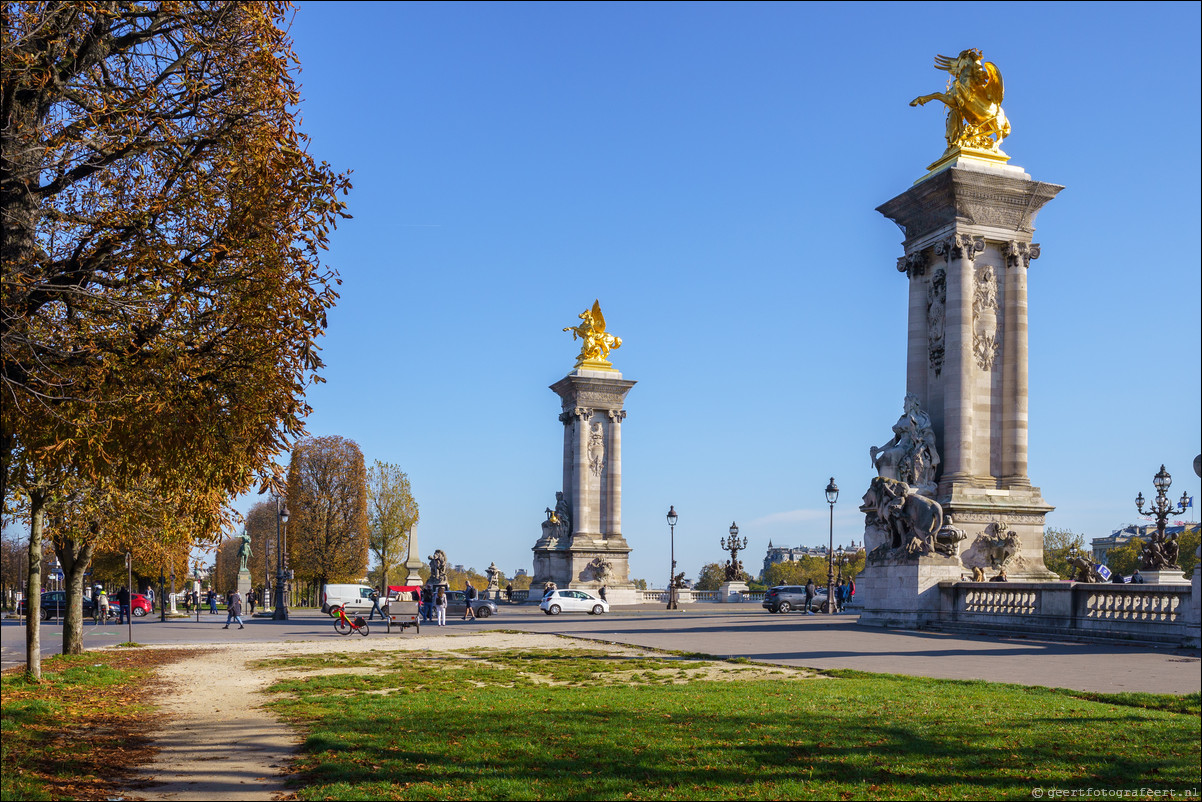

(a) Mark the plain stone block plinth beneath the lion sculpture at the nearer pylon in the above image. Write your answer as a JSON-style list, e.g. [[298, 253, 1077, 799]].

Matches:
[[856, 554, 964, 629]]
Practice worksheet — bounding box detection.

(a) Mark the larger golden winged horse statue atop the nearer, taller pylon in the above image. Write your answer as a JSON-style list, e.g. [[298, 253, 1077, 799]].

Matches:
[[910, 48, 1010, 154]]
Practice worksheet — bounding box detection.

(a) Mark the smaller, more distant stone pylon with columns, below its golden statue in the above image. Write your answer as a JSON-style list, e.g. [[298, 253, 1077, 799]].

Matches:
[[530, 369, 636, 604]]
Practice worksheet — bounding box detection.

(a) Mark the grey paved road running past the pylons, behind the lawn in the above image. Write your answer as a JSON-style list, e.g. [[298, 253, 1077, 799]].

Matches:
[[0, 604, 1202, 694]]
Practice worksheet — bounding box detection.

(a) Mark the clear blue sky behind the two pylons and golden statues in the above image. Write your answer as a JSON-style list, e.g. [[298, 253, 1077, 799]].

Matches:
[[227, 2, 1202, 584]]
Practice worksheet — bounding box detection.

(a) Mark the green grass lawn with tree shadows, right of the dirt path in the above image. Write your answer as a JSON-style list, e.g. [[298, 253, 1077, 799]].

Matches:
[[264, 649, 1202, 800]]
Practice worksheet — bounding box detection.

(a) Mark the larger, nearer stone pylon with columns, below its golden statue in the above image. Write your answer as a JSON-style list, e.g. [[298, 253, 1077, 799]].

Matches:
[[877, 159, 1064, 581]]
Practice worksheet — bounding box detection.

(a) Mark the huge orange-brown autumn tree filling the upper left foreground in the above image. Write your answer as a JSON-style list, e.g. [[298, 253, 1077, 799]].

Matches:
[[0, 1, 349, 677]]
